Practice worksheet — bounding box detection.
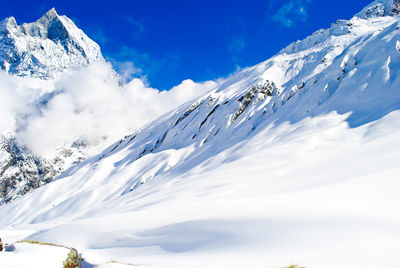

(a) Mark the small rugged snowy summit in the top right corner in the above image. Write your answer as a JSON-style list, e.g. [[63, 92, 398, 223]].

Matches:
[[356, 0, 400, 18]]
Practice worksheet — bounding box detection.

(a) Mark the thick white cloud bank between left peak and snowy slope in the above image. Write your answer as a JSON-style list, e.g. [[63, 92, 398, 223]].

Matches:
[[0, 63, 216, 157]]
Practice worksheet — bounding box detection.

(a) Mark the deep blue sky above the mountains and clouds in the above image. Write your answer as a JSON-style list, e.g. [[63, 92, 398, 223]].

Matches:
[[0, 0, 372, 89]]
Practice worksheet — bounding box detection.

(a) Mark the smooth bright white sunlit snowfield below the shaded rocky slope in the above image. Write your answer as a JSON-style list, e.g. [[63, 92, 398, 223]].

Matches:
[[0, 112, 400, 267]]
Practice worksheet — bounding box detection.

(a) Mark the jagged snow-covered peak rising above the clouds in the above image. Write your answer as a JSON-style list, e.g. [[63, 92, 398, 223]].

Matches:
[[0, 8, 104, 79]]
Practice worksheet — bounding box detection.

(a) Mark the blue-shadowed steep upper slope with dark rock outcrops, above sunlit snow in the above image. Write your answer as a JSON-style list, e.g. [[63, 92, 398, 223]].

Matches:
[[93, 12, 400, 180]]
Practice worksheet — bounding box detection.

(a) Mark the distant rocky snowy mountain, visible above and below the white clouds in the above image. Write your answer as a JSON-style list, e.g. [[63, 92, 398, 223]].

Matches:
[[0, 8, 104, 205]]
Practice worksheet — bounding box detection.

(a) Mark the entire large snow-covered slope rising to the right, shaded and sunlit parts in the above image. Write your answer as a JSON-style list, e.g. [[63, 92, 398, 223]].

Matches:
[[0, 0, 400, 267]]
